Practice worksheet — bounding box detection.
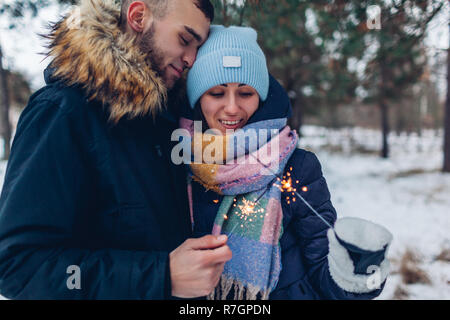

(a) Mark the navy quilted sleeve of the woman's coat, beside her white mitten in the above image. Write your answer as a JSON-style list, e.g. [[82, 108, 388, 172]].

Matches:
[[291, 150, 384, 299]]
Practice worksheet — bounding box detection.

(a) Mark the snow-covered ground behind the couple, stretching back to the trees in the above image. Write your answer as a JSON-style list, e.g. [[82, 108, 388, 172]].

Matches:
[[0, 126, 450, 299]]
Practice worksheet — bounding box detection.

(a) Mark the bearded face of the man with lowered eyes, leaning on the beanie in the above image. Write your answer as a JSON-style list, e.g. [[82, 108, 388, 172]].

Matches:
[[140, 0, 210, 89]]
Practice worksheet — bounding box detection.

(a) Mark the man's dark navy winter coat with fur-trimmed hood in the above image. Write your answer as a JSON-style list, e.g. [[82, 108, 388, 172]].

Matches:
[[0, 1, 192, 299]]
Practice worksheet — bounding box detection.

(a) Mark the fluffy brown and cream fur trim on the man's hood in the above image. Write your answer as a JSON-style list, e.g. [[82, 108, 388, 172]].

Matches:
[[46, 0, 167, 123]]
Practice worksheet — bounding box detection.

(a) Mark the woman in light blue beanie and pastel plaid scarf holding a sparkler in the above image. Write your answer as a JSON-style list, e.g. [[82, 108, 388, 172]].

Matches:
[[181, 26, 391, 299]]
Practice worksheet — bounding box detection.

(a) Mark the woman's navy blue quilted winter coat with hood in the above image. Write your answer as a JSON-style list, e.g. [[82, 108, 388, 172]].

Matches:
[[192, 77, 384, 300]]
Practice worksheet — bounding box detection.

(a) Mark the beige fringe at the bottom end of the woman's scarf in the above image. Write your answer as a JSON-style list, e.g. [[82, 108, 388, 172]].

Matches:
[[206, 275, 270, 300]]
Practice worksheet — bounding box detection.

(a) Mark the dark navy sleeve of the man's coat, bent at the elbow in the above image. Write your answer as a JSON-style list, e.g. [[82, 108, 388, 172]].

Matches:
[[0, 93, 171, 299]]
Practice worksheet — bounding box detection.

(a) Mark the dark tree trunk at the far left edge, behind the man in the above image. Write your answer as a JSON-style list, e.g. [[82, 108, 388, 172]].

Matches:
[[0, 42, 11, 160]]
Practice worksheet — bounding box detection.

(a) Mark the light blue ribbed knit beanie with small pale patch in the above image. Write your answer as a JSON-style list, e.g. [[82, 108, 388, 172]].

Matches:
[[187, 25, 269, 108]]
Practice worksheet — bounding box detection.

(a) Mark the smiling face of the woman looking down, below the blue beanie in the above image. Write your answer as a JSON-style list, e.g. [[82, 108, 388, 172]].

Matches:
[[200, 83, 259, 134]]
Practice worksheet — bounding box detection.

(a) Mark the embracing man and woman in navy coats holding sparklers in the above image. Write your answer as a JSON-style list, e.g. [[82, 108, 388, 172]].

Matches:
[[0, 0, 392, 300]]
